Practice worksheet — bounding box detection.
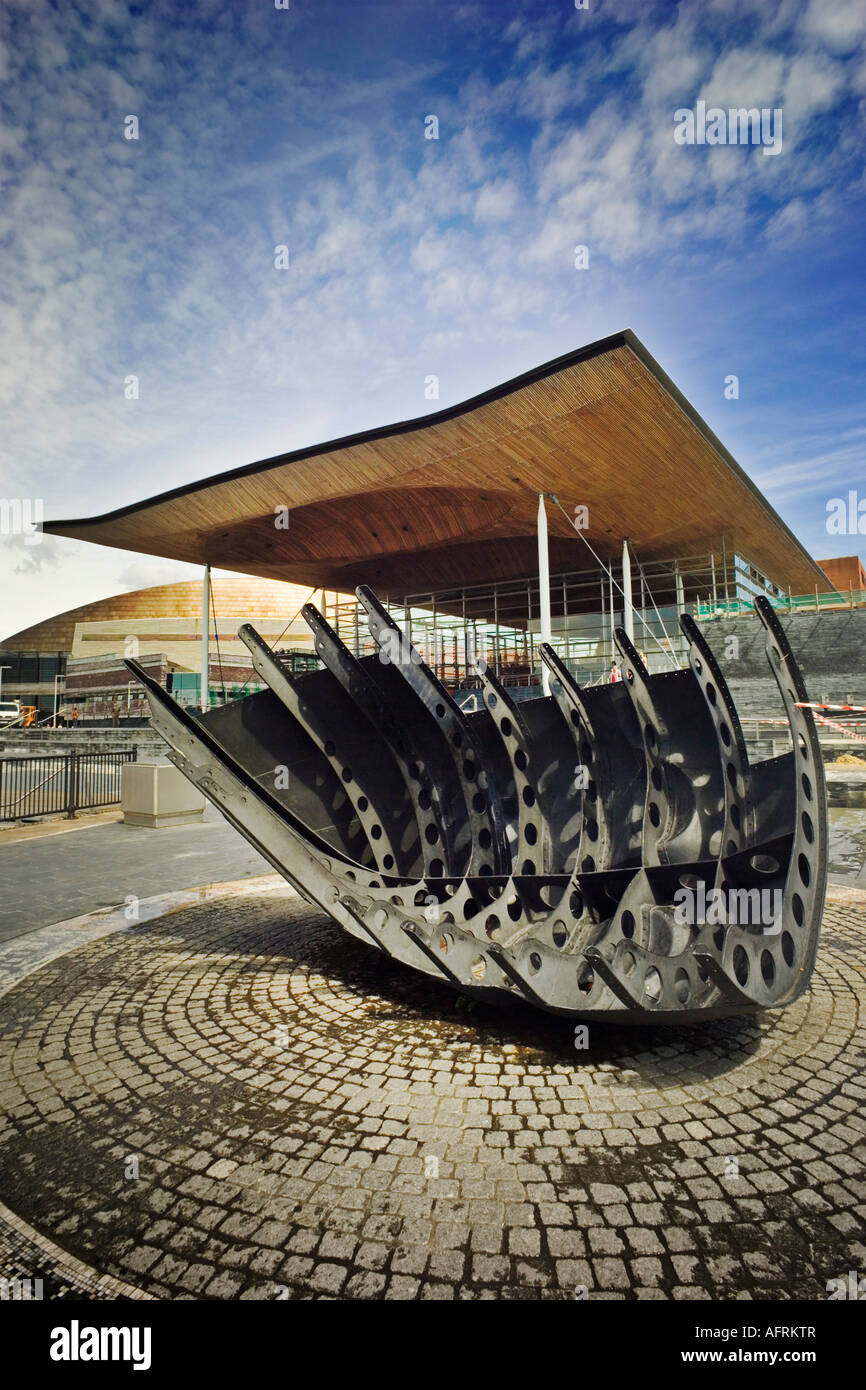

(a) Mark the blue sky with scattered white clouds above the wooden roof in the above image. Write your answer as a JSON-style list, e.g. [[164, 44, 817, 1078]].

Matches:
[[0, 0, 866, 632]]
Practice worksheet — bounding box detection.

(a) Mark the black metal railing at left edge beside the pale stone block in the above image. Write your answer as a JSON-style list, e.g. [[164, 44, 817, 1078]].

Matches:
[[0, 748, 138, 820]]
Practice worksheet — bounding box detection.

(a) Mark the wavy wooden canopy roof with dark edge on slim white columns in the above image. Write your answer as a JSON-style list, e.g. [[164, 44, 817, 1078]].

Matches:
[[44, 329, 828, 599]]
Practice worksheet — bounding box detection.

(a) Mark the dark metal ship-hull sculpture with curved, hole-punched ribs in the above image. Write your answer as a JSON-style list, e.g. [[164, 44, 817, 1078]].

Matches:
[[126, 588, 827, 1023]]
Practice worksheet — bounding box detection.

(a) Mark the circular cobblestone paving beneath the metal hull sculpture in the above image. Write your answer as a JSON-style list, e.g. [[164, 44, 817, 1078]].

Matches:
[[0, 892, 866, 1300]]
